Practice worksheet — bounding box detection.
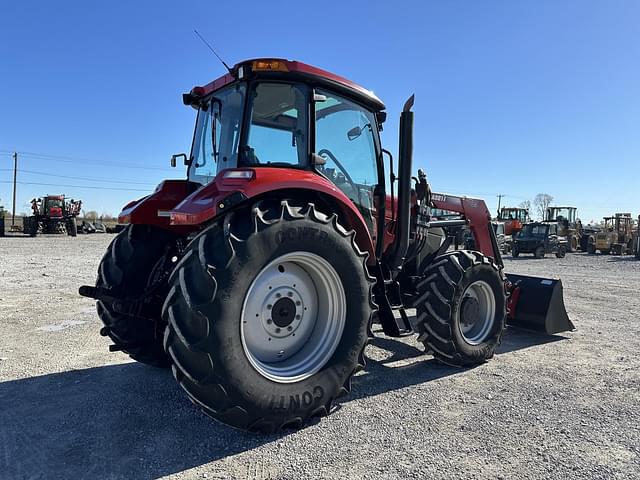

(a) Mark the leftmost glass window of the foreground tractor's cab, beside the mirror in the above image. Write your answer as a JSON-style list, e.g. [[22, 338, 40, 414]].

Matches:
[[188, 83, 246, 184]]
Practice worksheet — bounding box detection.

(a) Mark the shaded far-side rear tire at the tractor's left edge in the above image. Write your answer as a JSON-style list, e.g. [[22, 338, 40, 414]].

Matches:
[[96, 225, 176, 367]]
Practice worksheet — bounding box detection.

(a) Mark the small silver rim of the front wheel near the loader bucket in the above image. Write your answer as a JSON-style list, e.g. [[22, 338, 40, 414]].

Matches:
[[458, 280, 496, 345]]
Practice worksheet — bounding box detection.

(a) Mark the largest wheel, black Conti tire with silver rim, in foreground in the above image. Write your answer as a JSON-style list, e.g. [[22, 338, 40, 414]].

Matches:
[[163, 201, 374, 433]]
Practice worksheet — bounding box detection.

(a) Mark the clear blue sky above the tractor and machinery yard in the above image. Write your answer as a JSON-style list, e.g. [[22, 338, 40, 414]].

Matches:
[[0, 0, 640, 221]]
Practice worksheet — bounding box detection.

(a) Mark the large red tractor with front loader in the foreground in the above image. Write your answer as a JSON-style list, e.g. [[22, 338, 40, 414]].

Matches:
[[80, 59, 573, 432]]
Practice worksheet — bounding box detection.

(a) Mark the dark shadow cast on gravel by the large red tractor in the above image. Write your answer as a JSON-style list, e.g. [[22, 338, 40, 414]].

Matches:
[[0, 329, 562, 479]]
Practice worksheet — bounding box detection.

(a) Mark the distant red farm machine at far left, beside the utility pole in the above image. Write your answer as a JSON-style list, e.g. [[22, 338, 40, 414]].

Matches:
[[22, 195, 82, 237]]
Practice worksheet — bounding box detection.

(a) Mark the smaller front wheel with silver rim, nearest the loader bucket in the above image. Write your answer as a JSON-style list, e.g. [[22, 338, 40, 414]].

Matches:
[[416, 250, 506, 367]]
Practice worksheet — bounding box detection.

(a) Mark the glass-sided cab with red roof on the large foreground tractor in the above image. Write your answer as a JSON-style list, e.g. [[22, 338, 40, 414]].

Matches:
[[165, 59, 386, 251]]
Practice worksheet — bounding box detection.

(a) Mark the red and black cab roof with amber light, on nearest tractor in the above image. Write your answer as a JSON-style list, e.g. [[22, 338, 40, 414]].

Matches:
[[191, 58, 385, 111]]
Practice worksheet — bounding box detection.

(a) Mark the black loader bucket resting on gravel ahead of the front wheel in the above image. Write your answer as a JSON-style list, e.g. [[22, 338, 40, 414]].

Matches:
[[507, 273, 575, 335]]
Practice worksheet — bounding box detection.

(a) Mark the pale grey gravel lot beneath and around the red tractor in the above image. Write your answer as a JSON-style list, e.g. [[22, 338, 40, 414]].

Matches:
[[0, 235, 640, 480]]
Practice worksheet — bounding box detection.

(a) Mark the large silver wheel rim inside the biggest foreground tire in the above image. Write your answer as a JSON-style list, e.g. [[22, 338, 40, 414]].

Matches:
[[240, 252, 347, 383]]
